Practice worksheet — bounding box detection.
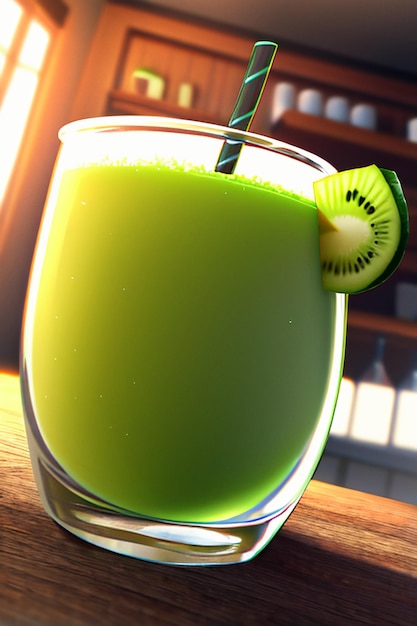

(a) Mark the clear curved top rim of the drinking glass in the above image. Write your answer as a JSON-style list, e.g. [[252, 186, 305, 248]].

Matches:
[[58, 115, 337, 175]]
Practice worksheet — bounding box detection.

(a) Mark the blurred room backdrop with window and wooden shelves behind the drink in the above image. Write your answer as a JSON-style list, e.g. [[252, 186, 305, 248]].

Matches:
[[0, 0, 417, 503]]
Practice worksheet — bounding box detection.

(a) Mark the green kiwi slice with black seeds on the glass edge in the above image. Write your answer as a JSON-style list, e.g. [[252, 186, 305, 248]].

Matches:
[[314, 165, 409, 293]]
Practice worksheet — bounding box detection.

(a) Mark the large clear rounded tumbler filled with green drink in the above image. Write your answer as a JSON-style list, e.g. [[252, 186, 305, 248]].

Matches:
[[21, 116, 346, 565]]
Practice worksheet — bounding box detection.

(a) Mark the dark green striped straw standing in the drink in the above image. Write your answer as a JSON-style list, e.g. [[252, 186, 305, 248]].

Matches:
[[216, 41, 278, 174]]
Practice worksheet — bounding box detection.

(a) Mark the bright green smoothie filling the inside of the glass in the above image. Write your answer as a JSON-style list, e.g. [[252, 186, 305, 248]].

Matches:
[[26, 164, 336, 522]]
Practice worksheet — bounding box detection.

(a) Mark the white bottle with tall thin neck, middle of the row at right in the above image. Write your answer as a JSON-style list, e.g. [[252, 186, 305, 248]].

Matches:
[[349, 337, 396, 445]]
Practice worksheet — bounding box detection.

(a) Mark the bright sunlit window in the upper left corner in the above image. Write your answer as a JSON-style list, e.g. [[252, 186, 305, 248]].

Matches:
[[0, 0, 53, 207]]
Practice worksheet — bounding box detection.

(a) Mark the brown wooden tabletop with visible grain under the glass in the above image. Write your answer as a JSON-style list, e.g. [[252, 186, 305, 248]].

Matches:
[[0, 374, 417, 626]]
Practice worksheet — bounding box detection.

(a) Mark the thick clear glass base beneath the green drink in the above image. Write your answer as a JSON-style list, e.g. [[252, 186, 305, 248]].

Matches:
[[32, 454, 296, 565]]
